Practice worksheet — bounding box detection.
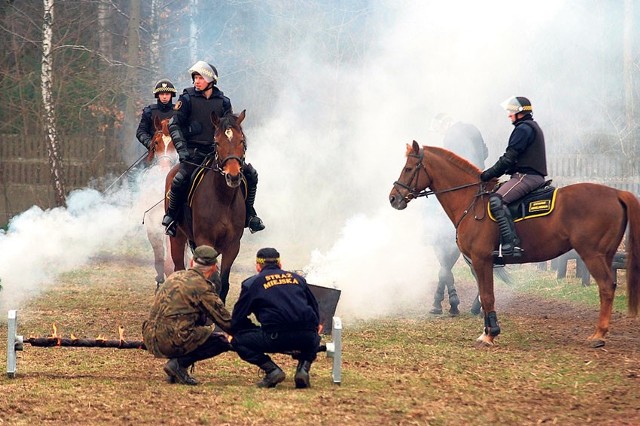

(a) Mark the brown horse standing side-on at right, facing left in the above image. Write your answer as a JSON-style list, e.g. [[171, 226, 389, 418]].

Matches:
[[389, 141, 640, 347]]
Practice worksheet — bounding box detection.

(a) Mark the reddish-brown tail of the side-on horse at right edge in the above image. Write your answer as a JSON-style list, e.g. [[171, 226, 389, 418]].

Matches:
[[618, 191, 640, 317]]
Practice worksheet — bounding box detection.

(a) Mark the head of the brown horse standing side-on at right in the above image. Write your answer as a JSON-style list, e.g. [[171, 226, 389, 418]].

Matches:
[[389, 141, 431, 210]]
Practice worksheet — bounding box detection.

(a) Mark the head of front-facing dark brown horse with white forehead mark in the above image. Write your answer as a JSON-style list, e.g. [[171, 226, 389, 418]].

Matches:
[[211, 110, 247, 188]]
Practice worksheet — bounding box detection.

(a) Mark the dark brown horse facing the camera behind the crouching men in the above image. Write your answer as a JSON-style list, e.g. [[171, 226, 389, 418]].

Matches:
[[165, 111, 246, 301]]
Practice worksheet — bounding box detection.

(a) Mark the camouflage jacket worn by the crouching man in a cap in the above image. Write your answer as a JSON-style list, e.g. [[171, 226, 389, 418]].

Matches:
[[142, 269, 231, 358]]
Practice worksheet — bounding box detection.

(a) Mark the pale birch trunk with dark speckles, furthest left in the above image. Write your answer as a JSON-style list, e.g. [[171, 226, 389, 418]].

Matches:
[[41, 0, 66, 206]]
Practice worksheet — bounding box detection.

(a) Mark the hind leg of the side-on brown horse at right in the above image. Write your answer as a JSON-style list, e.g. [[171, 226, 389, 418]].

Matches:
[[578, 252, 616, 348]]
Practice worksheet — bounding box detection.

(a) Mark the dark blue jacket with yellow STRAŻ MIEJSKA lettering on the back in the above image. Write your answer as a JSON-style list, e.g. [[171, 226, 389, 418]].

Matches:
[[231, 264, 320, 334]]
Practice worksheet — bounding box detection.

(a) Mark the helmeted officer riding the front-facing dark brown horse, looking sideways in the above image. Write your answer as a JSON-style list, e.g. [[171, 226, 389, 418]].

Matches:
[[162, 61, 264, 236]]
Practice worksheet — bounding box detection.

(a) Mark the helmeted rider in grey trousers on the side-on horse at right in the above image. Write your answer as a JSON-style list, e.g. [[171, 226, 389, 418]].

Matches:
[[480, 96, 547, 257]]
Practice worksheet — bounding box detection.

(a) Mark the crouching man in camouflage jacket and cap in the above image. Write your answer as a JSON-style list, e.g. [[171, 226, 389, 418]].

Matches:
[[142, 246, 231, 385]]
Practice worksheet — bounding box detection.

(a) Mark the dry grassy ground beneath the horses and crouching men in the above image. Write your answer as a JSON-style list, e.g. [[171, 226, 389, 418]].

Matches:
[[0, 243, 640, 425]]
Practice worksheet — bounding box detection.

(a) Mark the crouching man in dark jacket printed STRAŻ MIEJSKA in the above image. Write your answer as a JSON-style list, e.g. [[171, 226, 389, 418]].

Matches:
[[231, 248, 320, 388]]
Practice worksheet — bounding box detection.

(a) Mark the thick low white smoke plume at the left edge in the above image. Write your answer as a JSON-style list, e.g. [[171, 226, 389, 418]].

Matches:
[[0, 170, 168, 310]]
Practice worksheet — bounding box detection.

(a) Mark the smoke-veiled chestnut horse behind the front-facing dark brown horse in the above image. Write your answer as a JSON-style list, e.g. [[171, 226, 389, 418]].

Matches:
[[144, 117, 178, 285]]
